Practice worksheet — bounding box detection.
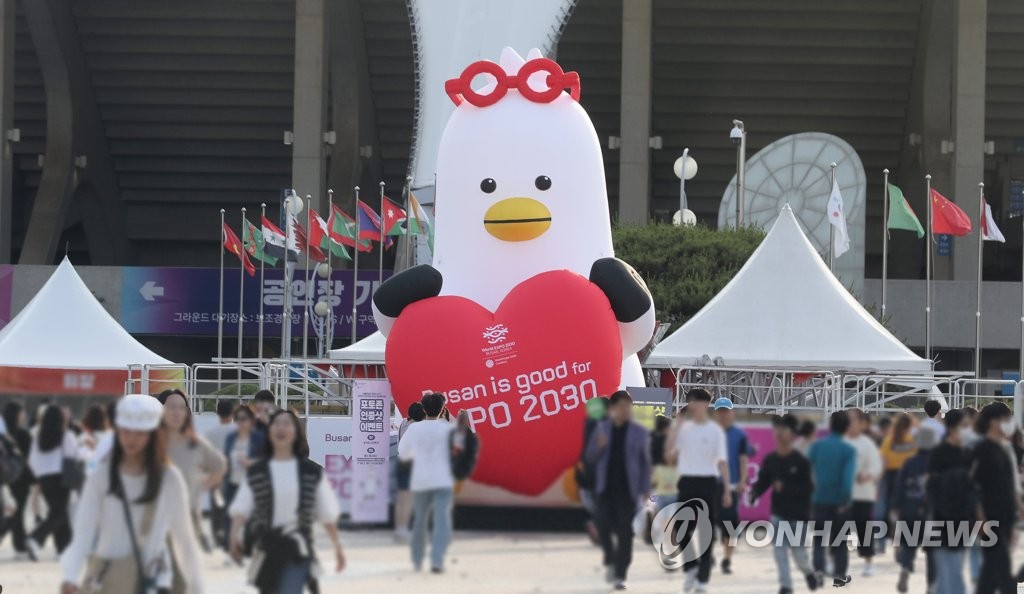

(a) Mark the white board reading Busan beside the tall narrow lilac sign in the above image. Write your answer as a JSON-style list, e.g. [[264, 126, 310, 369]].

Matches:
[[306, 417, 356, 513]]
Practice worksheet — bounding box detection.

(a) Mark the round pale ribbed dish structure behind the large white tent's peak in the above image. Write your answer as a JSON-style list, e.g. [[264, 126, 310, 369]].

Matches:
[[718, 132, 867, 292]]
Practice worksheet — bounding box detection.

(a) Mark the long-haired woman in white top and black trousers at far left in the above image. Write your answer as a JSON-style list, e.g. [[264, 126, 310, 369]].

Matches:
[[26, 406, 78, 561]]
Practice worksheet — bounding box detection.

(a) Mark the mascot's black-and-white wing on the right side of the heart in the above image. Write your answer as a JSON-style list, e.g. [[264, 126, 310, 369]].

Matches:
[[590, 258, 654, 355]]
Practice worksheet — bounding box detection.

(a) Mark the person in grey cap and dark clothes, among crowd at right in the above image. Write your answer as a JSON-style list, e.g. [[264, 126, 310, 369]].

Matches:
[[888, 425, 939, 592]]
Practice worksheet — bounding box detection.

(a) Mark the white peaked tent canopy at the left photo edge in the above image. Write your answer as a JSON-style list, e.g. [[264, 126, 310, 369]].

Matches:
[[0, 257, 172, 370]]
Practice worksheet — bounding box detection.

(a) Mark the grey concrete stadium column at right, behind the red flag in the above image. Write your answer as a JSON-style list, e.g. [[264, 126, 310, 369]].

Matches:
[[948, 0, 988, 281]]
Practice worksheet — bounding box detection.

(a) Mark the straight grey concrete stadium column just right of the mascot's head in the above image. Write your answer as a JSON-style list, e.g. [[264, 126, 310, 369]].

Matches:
[[618, 0, 653, 224]]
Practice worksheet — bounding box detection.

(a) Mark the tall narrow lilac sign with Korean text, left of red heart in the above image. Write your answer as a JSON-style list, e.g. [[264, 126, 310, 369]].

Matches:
[[351, 380, 391, 523]]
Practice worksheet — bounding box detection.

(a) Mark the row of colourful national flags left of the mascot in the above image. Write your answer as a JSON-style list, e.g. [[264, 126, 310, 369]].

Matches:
[[222, 194, 433, 277]]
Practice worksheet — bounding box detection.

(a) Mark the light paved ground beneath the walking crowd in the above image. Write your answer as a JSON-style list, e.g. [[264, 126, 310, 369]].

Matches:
[[0, 532, 991, 594]]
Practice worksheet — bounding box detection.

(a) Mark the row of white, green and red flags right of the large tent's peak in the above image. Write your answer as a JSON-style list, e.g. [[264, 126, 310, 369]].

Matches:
[[826, 180, 1007, 257]]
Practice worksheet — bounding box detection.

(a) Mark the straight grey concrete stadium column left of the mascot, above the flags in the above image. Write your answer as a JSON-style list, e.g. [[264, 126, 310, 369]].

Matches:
[[292, 0, 327, 212]]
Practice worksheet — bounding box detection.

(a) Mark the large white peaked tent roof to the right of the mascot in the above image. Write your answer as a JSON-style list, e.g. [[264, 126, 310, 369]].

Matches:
[[645, 205, 932, 373]]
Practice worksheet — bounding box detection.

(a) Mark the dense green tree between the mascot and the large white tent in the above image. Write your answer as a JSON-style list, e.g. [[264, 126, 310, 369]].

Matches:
[[611, 224, 765, 330]]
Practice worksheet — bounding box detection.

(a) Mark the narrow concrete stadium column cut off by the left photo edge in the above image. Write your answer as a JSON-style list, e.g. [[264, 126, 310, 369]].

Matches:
[[0, 0, 15, 264]]
